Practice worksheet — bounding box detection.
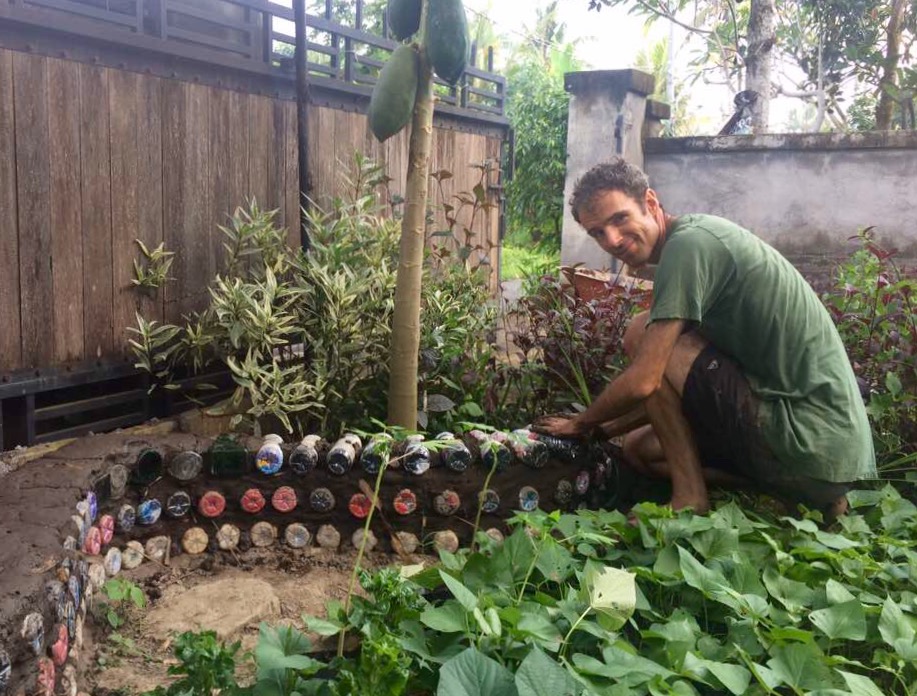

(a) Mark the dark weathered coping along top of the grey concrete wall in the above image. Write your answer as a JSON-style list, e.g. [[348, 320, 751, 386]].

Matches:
[[644, 130, 917, 155]]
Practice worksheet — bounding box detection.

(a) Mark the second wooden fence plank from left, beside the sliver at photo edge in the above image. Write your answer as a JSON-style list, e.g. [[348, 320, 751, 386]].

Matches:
[[13, 53, 54, 367]]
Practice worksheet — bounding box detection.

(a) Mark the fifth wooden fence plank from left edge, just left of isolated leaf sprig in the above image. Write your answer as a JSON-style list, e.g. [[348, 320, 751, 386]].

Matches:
[[108, 70, 140, 353]]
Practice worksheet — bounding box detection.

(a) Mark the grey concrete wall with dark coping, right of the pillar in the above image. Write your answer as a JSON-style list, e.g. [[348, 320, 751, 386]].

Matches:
[[644, 132, 917, 258]]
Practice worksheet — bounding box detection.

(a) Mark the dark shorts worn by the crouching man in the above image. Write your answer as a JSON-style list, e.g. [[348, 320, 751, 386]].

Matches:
[[681, 344, 850, 508]]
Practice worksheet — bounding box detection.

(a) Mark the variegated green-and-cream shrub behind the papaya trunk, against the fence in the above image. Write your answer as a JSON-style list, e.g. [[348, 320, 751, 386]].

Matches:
[[131, 155, 495, 434]]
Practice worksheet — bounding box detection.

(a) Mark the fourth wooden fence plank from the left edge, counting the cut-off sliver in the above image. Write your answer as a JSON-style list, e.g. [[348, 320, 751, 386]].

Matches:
[[80, 65, 114, 358]]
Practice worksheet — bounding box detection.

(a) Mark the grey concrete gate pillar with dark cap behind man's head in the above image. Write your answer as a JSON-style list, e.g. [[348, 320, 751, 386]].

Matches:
[[560, 70, 654, 270]]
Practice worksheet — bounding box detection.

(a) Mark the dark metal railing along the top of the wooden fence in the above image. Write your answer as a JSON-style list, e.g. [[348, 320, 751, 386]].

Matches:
[[0, 0, 506, 115]]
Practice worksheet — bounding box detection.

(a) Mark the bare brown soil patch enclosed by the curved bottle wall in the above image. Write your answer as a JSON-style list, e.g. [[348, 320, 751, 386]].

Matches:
[[87, 549, 397, 696]]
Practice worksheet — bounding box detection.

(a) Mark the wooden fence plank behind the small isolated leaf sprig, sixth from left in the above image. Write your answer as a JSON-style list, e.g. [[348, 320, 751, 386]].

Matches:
[[137, 75, 164, 321]]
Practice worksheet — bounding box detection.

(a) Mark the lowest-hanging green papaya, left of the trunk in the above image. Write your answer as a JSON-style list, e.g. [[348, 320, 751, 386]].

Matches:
[[369, 45, 420, 142]]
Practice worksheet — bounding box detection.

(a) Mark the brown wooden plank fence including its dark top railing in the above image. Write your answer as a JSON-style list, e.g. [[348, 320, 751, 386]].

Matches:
[[0, 0, 506, 381]]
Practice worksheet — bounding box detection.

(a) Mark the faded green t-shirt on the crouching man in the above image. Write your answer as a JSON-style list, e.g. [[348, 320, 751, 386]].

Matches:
[[650, 215, 876, 482]]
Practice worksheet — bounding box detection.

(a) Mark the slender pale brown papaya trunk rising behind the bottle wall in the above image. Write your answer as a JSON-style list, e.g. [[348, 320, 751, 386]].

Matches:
[[388, 57, 433, 430]]
